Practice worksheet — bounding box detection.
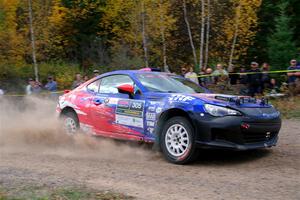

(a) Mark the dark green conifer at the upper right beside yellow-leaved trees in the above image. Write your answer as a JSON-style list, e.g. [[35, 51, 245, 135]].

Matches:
[[267, 1, 296, 69]]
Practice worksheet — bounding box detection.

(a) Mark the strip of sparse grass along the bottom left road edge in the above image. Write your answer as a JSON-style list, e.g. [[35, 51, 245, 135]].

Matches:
[[0, 186, 133, 200]]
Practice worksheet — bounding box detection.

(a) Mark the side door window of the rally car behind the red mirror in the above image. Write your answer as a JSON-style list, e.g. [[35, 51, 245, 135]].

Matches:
[[99, 75, 134, 94]]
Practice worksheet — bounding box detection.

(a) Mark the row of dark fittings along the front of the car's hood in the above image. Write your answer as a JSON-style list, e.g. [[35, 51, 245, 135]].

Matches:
[[215, 96, 269, 105]]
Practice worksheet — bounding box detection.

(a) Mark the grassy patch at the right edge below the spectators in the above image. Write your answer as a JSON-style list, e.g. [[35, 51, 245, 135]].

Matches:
[[271, 96, 300, 119]]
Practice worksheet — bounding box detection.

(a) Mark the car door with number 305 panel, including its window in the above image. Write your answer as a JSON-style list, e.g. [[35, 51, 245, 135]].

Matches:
[[90, 74, 145, 140]]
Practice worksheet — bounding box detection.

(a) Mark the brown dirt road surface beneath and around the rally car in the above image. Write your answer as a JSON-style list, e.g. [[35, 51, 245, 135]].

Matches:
[[0, 96, 300, 199]]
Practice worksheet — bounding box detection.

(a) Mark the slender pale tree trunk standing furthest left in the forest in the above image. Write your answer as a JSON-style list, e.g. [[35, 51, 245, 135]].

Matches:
[[28, 0, 39, 81]]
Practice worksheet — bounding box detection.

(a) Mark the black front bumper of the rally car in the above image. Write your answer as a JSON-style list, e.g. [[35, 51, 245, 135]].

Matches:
[[194, 114, 281, 150]]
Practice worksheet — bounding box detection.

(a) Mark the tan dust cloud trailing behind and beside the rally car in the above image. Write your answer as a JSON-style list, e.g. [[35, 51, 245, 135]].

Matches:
[[0, 97, 160, 160]]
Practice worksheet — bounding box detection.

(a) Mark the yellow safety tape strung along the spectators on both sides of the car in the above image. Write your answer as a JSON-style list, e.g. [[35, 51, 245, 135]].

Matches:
[[4, 69, 300, 97]]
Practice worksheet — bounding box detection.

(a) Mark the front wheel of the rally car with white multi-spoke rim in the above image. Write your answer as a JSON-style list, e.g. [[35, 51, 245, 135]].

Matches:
[[160, 117, 197, 164]]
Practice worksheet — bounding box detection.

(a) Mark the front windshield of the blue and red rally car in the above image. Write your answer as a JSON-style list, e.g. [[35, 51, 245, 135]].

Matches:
[[136, 73, 205, 93]]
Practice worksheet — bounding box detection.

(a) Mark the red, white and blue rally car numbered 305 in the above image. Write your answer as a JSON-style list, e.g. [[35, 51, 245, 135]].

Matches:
[[57, 70, 281, 164]]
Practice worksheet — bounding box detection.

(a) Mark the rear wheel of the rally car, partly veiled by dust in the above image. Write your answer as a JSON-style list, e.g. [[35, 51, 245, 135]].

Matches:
[[61, 111, 79, 135]]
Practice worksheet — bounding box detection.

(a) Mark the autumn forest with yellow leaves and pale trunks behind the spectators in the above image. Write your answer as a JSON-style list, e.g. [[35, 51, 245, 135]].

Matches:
[[0, 0, 300, 90]]
